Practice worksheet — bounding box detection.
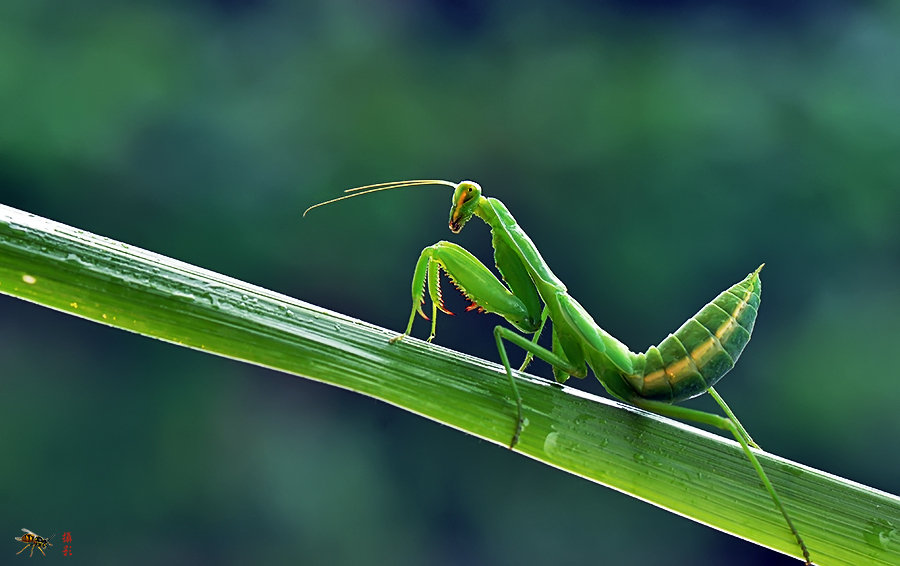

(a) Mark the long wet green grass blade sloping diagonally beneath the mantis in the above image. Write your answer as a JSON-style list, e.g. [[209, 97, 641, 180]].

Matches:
[[0, 205, 900, 565]]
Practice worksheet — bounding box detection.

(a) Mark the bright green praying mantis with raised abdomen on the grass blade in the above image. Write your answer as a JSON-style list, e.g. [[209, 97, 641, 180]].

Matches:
[[303, 179, 812, 564]]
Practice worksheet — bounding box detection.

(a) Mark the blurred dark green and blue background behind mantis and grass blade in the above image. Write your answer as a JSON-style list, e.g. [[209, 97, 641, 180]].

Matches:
[[0, 0, 900, 566]]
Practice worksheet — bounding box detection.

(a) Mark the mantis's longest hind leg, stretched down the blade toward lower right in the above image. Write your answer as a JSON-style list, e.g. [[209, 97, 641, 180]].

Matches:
[[630, 398, 812, 564]]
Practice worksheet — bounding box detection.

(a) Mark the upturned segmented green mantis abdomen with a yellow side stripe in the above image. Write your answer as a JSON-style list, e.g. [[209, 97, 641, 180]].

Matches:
[[627, 266, 762, 403]]
